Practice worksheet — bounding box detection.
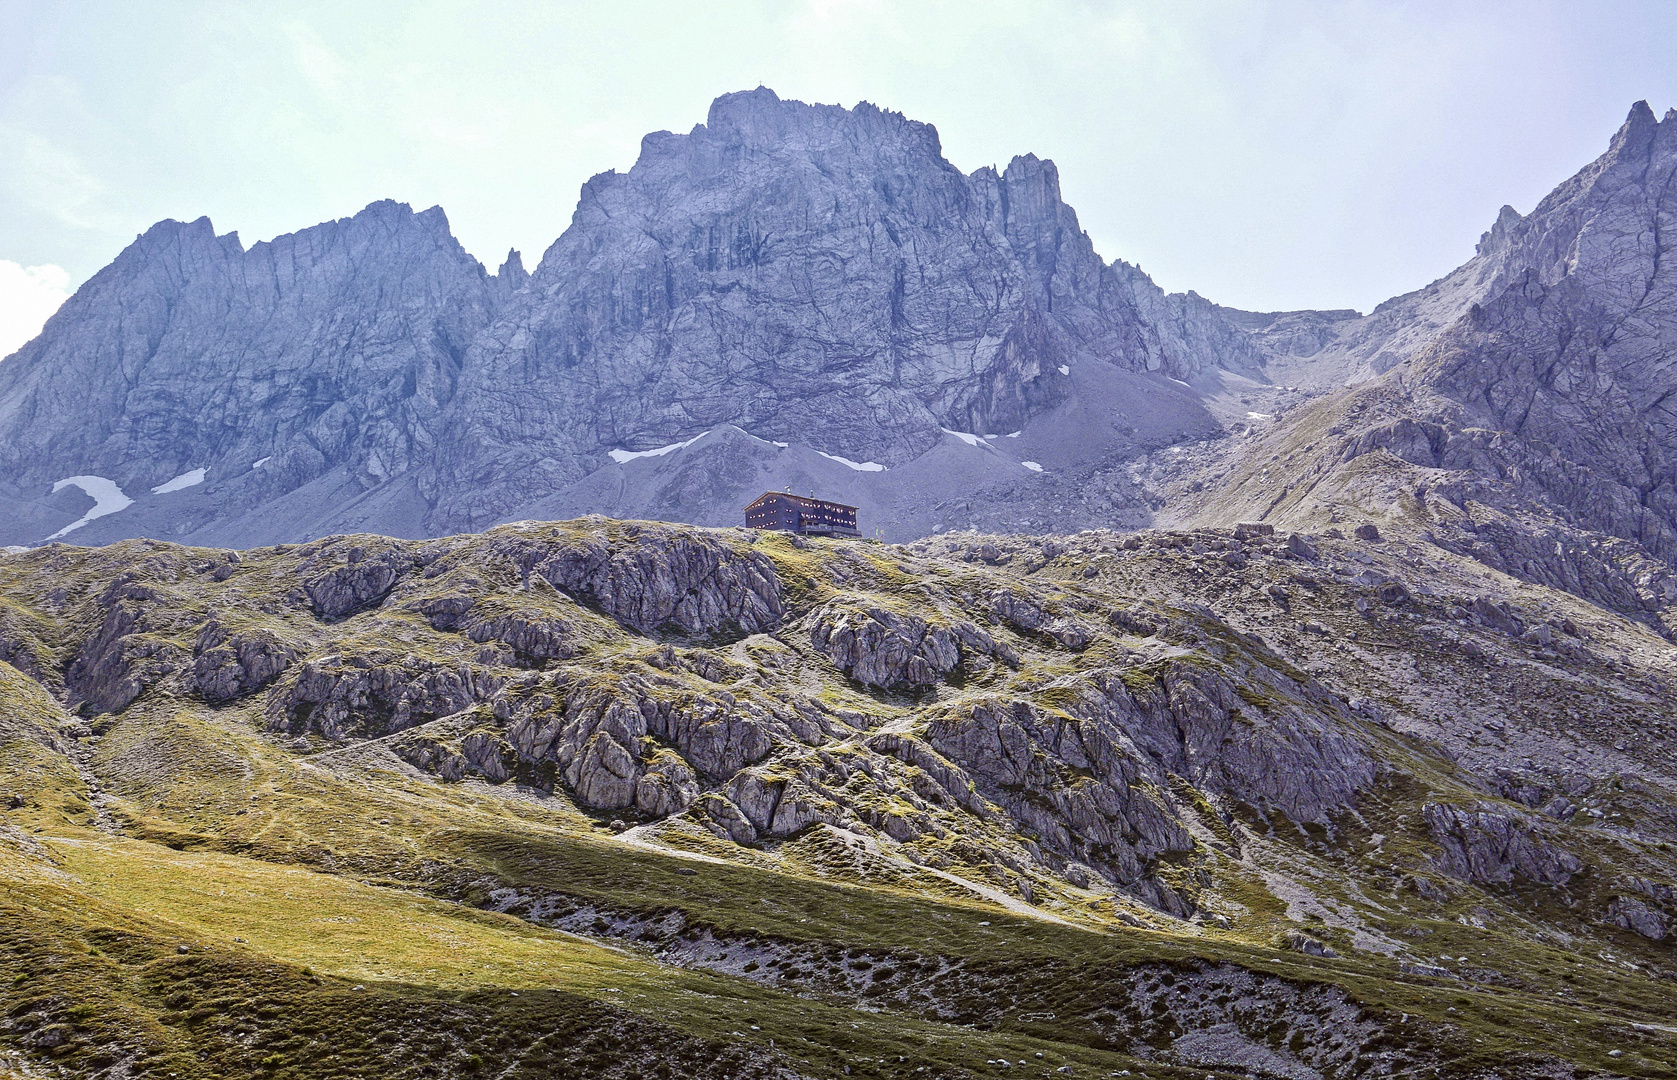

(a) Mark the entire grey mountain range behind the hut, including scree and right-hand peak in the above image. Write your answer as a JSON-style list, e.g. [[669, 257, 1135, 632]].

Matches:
[[0, 87, 1677, 600]]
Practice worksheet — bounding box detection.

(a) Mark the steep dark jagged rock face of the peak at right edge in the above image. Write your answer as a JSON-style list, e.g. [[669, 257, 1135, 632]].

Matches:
[[1419, 102, 1677, 562]]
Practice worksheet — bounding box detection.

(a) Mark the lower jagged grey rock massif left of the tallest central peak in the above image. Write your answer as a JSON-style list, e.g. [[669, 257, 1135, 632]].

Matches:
[[0, 203, 496, 543]]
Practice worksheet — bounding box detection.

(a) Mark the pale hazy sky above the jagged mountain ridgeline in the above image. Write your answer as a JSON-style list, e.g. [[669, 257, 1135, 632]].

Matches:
[[0, 0, 1677, 356]]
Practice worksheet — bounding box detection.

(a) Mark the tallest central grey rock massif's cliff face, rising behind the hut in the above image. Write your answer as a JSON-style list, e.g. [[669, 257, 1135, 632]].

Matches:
[[425, 89, 1251, 527]]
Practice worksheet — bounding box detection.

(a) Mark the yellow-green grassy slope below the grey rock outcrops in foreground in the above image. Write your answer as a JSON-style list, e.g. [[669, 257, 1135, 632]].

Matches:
[[0, 526, 1677, 1077]]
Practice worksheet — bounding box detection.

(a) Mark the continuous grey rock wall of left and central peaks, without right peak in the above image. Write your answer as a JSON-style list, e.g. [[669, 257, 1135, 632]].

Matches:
[[0, 89, 1259, 543]]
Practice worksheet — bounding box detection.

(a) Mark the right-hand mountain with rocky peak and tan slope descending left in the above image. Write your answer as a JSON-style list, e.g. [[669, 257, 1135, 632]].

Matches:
[[1167, 102, 1677, 634]]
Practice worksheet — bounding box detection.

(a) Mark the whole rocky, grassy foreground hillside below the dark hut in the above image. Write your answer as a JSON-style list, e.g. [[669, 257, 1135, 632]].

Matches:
[[0, 518, 1677, 1080]]
